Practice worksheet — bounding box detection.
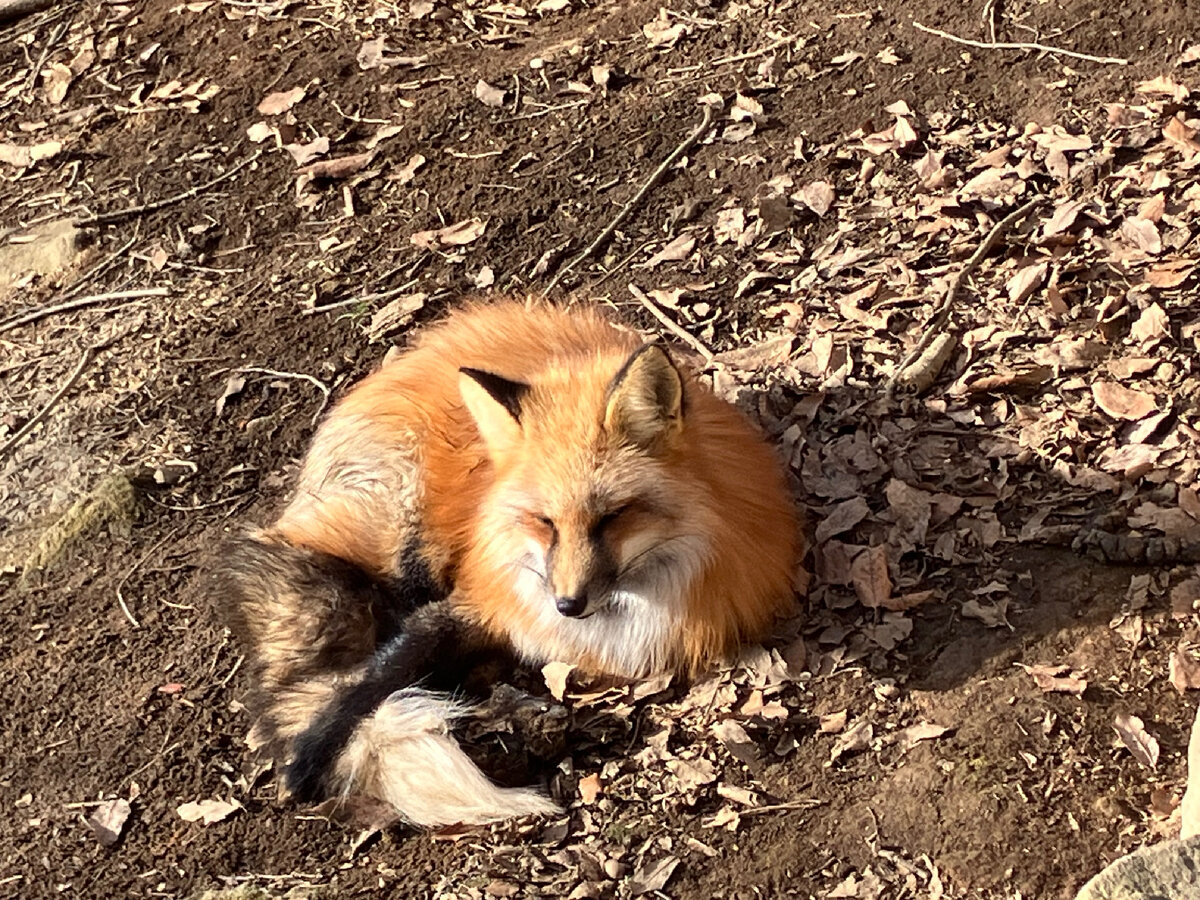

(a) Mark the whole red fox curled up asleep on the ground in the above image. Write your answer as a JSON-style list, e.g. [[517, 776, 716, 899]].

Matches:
[[220, 301, 800, 827]]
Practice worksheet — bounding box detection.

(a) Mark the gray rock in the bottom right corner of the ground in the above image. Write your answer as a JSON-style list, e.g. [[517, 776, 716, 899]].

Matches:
[[1075, 838, 1200, 900]]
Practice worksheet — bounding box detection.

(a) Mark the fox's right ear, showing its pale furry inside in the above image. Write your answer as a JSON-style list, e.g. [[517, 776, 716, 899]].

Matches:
[[604, 343, 683, 450]]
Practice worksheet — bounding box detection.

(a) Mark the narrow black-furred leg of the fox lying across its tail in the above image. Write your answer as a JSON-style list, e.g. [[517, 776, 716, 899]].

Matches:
[[284, 602, 485, 803]]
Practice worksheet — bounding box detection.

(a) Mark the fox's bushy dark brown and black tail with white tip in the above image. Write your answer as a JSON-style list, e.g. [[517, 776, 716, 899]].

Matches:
[[220, 535, 557, 827]]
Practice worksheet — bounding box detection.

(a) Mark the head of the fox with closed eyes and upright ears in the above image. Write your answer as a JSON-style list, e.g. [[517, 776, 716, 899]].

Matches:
[[460, 344, 707, 618]]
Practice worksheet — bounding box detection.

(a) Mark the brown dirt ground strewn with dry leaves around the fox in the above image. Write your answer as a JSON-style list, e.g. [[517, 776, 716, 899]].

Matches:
[[0, 0, 1200, 900]]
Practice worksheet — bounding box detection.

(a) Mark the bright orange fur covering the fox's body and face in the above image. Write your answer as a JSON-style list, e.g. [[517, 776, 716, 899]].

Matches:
[[272, 302, 799, 676]]
